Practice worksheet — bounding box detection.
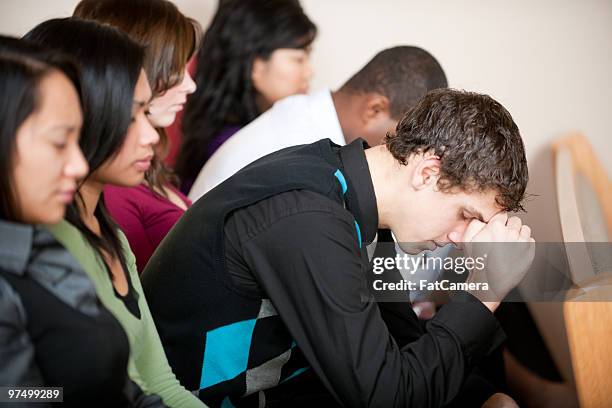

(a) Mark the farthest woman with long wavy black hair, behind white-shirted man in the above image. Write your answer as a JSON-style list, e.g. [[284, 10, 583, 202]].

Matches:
[[175, 0, 316, 193]]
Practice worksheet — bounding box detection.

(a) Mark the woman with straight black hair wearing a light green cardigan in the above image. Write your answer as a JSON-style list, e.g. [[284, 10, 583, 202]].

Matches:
[[26, 18, 202, 407]]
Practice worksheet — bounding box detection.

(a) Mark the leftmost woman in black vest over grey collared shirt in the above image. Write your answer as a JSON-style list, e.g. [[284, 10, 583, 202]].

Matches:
[[0, 36, 143, 407]]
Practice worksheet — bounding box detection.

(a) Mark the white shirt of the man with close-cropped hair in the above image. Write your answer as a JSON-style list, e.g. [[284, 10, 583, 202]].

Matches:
[[189, 89, 346, 201]]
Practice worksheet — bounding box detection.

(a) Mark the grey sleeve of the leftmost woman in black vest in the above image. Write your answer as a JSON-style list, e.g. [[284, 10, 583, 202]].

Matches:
[[0, 277, 43, 388]]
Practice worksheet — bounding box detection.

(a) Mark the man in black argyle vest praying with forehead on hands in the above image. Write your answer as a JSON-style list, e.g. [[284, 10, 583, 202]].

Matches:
[[142, 89, 533, 407]]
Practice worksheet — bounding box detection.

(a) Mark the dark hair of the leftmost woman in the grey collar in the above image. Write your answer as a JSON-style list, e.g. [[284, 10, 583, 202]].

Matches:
[[0, 35, 81, 221]]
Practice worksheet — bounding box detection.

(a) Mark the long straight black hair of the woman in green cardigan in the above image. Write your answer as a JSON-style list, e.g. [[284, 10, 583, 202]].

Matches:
[[24, 18, 144, 272]]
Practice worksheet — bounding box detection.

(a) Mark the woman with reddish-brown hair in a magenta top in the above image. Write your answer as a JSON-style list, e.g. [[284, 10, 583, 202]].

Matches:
[[74, 0, 200, 273]]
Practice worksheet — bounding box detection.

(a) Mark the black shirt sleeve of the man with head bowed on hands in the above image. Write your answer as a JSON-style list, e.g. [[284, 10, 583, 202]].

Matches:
[[242, 211, 504, 407]]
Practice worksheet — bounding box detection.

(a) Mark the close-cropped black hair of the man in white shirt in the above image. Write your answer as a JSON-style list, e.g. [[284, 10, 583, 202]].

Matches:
[[340, 46, 448, 119]]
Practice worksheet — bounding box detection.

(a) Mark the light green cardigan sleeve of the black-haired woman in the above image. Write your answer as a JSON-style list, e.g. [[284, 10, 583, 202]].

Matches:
[[118, 234, 206, 408]]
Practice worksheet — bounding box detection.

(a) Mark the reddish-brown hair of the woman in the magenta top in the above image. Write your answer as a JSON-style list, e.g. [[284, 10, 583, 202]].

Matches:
[[74, 0, 201, 195]]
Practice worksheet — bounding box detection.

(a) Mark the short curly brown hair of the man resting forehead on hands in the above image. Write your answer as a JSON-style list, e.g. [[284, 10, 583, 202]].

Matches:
[[385, 89, 529, 211]]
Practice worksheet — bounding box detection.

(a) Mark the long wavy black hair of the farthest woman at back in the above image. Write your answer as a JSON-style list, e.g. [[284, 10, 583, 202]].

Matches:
[[175, 0, 317, 182]]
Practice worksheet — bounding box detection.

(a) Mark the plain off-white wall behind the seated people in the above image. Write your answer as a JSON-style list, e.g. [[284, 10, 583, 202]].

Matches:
[[0, 0, 612, 380]]
